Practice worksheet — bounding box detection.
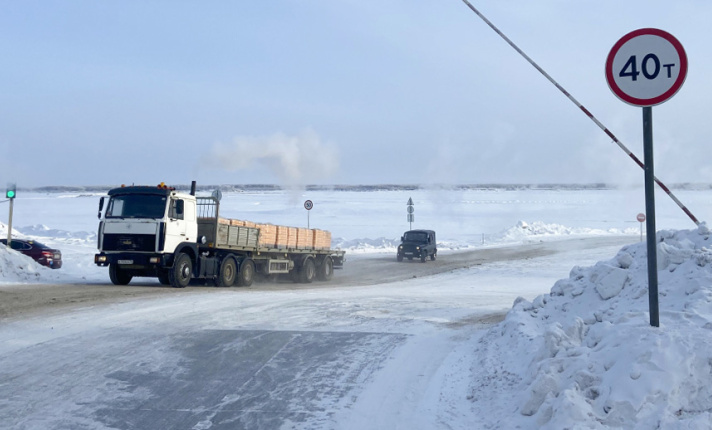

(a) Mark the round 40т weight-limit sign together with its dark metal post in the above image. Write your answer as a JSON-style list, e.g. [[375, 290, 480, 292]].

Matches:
[[606, 28, 687, 327]]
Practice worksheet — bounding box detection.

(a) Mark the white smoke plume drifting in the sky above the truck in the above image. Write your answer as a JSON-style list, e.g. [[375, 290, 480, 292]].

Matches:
[[203, 130, 339, 185]]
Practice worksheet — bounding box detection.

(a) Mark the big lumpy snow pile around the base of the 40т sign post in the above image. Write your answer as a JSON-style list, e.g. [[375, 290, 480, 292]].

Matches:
[[470, 225, 712, 429]]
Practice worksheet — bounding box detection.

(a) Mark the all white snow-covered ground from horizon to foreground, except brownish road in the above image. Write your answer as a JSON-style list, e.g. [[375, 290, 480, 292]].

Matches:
[[0, 189, 712, 429]]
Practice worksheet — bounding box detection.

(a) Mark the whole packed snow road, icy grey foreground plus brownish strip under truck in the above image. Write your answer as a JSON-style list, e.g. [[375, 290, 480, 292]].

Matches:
[[0, 236, 633, 429]]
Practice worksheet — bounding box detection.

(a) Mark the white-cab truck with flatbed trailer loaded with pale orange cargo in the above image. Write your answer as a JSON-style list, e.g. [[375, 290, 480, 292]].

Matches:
[[94, 181, 345, 288]]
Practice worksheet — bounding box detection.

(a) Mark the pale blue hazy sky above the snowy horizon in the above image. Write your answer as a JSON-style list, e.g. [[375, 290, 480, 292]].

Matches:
[[0, 0, 712, 186]]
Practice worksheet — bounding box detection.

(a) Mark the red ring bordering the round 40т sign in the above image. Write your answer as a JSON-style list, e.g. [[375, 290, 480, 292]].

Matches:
[[606, 28, 687, 106]]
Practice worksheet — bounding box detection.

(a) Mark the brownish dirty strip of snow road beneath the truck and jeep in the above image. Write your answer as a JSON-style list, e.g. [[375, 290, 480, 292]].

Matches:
[[0, 236, 631, 319]]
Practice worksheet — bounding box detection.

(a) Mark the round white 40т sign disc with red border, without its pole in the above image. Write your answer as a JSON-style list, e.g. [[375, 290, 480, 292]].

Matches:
[[606, 28, 687, 106]]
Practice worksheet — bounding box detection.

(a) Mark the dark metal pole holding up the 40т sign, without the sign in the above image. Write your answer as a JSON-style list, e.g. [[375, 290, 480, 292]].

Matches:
[[643, 106, 660, 327]]
